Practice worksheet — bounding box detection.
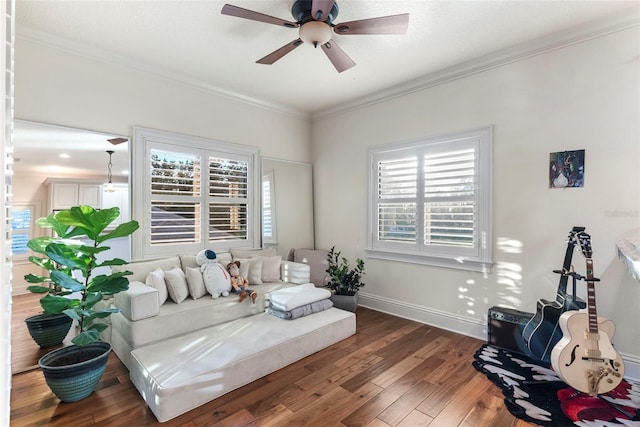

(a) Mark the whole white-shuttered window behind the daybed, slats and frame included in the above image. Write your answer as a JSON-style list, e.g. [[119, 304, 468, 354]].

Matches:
[[132, 128, 260, 259]]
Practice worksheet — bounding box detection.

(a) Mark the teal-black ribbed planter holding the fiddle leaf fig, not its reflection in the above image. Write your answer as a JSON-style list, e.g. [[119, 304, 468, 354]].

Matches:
[[38, 341, 111, 402]]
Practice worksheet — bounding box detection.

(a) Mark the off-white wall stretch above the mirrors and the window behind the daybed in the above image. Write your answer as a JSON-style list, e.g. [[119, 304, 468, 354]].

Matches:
[[15, 37, 311, 162]]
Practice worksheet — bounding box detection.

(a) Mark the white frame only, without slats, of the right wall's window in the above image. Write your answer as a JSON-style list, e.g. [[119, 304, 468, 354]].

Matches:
[[366, 126, 493, 272]]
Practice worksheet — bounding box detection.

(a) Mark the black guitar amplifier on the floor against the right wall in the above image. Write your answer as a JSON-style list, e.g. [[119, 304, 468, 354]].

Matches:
[[488, 306, 533, 356]]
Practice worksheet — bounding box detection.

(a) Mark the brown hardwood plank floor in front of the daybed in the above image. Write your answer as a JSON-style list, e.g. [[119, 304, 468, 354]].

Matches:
[[11, 295, 531, 427]]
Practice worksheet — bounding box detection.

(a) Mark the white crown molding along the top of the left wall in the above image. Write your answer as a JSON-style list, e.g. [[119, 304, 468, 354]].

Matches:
[[16, 25, 310, 119]]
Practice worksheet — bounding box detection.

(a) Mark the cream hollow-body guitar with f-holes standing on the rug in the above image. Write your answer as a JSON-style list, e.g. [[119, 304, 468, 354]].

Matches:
[[551, 232, 624, 396]]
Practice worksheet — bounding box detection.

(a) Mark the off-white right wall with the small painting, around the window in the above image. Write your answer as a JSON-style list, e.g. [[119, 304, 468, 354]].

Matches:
[[312, 27, 640, 372]]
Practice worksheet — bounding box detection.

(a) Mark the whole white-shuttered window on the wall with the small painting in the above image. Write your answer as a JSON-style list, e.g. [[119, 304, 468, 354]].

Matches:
[[367, 128, 492, 271]]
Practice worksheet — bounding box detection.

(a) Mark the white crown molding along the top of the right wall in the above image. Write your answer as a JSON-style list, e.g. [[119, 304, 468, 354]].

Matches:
[[311, 6, 640, 121]]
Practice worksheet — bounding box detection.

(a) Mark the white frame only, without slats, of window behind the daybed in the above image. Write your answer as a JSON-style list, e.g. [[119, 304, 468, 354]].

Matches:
[[131, 126, 261, 259]]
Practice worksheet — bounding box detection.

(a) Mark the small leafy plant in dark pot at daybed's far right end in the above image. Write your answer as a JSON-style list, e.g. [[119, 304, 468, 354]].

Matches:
[[326, 246, 364, 312]]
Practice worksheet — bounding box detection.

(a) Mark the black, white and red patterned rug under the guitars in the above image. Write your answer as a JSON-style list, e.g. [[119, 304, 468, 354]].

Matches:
[[473, 344, 640, 427]]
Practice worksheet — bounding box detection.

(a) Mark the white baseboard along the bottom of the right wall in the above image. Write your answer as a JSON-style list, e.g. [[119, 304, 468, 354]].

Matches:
[[358, 291, 640, 381]]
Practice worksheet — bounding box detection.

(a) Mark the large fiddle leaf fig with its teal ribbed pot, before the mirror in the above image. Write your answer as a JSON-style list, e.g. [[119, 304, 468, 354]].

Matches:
[[25, 206, 139, 402]]
